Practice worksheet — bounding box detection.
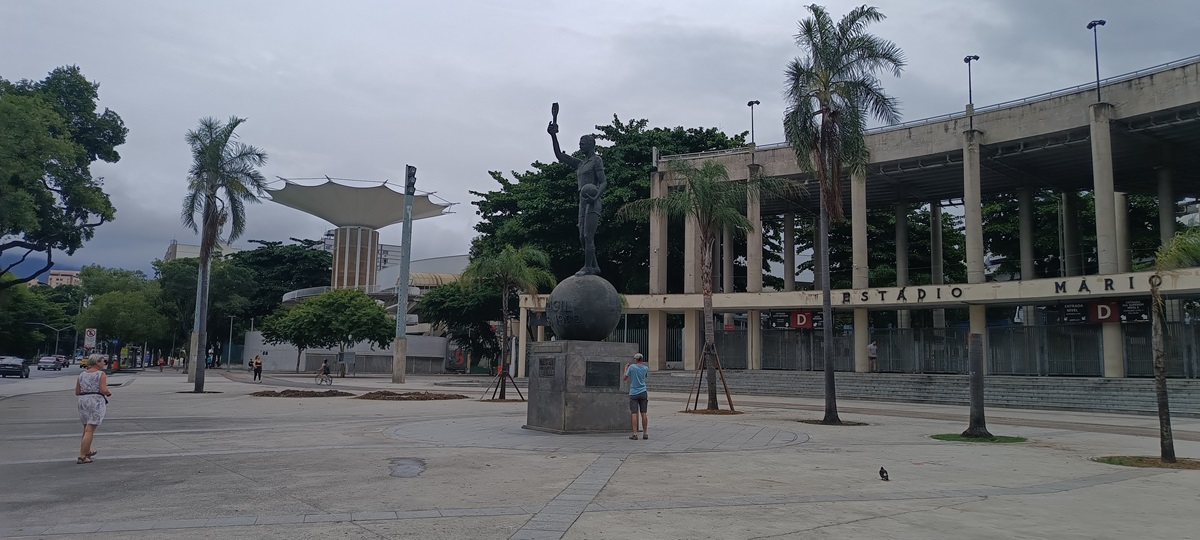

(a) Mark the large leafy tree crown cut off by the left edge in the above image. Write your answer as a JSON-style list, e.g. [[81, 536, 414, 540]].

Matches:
[[0, 66, 127, 289]]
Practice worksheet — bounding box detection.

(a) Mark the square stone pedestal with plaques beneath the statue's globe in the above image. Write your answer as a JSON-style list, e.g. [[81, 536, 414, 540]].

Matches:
[[522, 340, 637, 434]]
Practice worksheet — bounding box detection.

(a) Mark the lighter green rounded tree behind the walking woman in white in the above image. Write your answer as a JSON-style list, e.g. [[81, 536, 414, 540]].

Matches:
[[76, 287, 168, 364]]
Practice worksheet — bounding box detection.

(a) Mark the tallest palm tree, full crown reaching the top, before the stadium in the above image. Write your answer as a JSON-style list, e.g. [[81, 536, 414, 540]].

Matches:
[[784, 5, 905, 424]]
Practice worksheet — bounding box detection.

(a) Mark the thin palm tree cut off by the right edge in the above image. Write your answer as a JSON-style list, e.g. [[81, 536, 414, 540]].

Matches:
[[1150, 227, 1200, 463]]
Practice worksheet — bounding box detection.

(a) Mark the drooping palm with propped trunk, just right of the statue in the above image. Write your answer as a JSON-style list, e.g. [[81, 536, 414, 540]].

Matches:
[[618, 161, 800, 410]]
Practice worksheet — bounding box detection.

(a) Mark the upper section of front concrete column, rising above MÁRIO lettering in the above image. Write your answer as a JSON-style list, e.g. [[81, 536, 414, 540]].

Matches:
[[1088, 103, 1117, 274]]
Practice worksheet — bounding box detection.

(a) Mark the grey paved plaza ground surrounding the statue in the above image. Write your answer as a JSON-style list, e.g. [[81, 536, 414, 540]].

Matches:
[[0, 370, 1200, 540]]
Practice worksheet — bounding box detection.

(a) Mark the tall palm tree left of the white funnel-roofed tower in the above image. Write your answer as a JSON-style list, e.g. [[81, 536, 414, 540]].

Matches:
[[181, 116, 266, 392]]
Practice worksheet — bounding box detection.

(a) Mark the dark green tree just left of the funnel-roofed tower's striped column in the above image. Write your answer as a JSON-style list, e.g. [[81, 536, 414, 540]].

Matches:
[[228, 238, 332, 318]]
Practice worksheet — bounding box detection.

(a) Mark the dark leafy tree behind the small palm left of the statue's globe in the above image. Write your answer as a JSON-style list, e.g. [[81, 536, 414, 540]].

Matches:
[[420, 282, 503, 371]]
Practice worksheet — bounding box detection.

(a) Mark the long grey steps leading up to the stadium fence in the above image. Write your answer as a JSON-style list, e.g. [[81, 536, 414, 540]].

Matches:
[[648, 370, 1200, 418]]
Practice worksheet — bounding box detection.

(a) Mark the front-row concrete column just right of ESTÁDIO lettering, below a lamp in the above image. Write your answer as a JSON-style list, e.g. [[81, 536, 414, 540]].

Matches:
[[962, 130, 988, 361]]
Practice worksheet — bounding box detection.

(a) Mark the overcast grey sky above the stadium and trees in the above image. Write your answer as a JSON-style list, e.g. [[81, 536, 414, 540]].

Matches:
[[0, 0, 1200, 276]]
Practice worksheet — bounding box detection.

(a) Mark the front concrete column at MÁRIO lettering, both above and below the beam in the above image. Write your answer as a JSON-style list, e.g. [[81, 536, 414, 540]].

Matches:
[[1088, 103, 1124, 377]]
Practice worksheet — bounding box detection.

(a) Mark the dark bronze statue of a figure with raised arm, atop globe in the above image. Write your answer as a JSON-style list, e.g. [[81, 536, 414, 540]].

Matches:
[[546, 103, 608, 276]]
